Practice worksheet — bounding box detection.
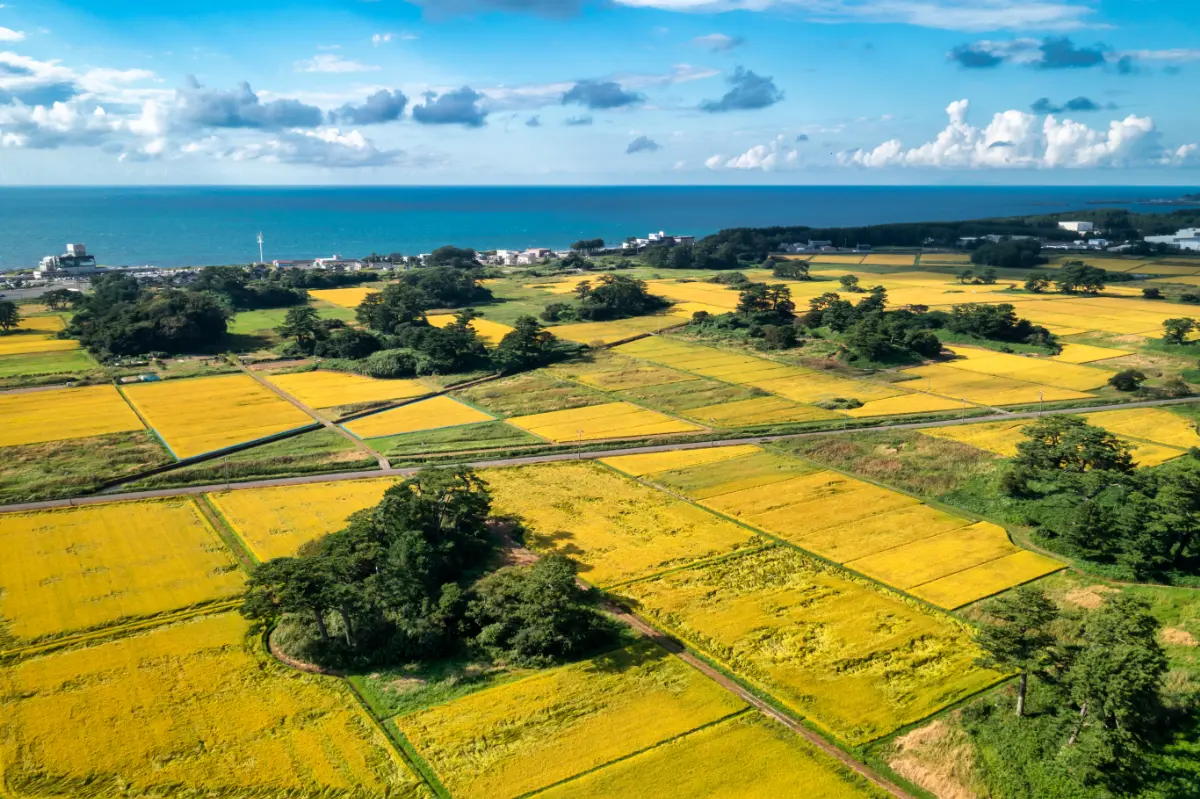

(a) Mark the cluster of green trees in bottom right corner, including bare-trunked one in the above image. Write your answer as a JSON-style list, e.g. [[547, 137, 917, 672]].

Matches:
[[961, 588, 1187, 799]]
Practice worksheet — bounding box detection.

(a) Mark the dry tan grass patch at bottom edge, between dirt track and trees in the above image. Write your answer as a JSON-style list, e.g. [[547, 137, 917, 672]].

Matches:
[[888, 720, 979, 799]]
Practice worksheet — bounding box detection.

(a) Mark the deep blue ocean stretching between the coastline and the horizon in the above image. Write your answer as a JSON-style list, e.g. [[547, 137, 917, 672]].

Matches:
[[0, 186, 1196, 270]]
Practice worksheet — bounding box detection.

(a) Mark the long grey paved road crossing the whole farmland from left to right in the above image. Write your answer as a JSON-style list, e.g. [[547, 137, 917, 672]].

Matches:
[[0, 397, 1198, 513]]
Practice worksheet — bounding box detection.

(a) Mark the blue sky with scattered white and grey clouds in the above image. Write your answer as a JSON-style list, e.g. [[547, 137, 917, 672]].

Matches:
[[0, 0, 1200, 186]]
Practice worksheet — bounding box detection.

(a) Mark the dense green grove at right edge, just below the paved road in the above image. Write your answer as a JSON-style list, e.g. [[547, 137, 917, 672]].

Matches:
[[1002, 415, 1200, 581]]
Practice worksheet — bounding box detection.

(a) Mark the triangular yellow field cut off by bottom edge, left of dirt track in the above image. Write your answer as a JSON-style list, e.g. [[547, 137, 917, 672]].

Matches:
[[538, 713, 889, 799]]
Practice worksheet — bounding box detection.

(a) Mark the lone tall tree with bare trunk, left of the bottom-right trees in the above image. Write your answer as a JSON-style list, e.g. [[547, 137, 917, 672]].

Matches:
[[976, 587, 1058, 716]]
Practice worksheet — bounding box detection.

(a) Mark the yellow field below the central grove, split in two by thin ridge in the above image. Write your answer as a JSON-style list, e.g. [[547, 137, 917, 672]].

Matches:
[[394, 642, 882, 799]]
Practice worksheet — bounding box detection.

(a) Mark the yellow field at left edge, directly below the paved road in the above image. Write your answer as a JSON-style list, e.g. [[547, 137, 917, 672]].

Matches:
[[0, 499, 246, 642]]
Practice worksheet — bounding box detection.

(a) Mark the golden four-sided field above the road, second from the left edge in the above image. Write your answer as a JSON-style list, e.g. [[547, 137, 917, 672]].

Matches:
[[124, 374, 314, 458]]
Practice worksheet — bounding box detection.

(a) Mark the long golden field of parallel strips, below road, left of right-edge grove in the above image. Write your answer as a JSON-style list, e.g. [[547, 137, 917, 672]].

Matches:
[[605, 447, 1062, 608]]
